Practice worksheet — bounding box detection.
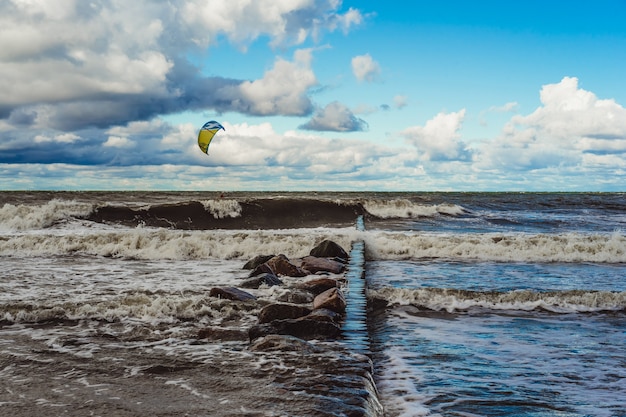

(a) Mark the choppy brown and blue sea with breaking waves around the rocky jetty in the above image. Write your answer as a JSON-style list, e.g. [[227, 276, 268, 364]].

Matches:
[[0, 191, 626, 417]]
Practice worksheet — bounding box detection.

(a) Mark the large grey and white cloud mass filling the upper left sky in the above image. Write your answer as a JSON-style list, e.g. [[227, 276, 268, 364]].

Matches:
[[0, 0, 362, 131]]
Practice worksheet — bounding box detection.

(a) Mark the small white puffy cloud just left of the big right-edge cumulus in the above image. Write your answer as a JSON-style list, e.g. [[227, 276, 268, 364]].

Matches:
[[400, 109, 469, 161]]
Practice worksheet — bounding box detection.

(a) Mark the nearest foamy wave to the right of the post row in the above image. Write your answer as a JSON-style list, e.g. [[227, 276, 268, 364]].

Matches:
[[368, 288, 626, 313]]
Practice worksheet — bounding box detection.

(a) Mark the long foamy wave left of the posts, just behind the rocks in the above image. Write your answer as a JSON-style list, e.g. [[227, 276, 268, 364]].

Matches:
[[0, 228, 357, 260]]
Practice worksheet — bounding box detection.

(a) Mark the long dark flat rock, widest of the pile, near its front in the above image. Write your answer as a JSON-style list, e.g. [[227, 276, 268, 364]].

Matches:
[[248, 316, 341, 341]]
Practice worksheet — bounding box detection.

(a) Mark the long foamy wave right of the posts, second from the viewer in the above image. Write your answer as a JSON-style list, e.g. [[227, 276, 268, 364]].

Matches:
[[364, 232, 626, 263]]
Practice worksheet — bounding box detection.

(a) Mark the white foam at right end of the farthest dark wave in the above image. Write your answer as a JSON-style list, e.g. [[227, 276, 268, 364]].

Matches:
[[363, 199, 465, 219]]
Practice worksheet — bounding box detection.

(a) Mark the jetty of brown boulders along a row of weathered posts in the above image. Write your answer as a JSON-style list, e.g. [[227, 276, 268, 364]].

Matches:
[[198, 240, 383, 417]]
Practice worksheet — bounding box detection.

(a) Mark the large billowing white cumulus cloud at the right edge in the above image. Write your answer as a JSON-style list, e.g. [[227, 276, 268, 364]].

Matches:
[[477, 77, 626, 170]]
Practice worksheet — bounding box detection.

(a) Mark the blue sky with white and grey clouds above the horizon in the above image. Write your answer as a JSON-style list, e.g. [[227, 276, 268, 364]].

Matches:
[[0, 0, 626, 191]]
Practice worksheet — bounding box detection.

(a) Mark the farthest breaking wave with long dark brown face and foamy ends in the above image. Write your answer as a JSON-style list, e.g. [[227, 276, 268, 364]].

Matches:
[[0, 196, 468, 231]]
